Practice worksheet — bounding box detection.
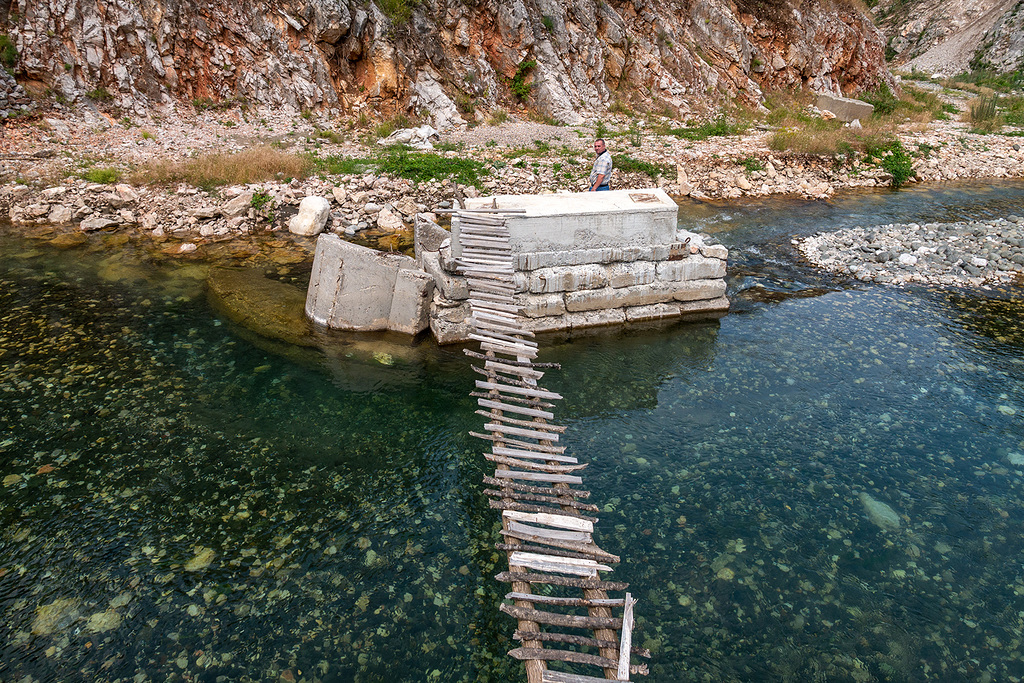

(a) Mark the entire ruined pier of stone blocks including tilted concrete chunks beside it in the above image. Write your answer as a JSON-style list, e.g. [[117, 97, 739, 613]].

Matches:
[[306, 189, 729, 344]]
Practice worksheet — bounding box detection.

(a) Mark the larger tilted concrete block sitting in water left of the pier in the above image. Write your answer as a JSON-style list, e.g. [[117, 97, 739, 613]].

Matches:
[[306, 234, 416, 332]]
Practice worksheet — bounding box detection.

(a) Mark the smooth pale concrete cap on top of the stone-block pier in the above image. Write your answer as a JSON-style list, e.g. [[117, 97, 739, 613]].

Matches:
[[462, 188, 678, 256]]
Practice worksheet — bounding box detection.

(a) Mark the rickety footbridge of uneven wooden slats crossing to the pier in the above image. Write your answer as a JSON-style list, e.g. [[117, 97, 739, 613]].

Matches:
[[457, 209, 650, 683]]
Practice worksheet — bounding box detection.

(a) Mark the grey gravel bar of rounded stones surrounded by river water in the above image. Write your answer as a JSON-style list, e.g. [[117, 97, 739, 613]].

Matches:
[[794, 216, 1024, 286]]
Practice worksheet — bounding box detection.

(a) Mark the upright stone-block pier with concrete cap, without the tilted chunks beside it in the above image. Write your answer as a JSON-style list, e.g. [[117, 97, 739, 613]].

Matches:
[[416, 189, 729, 344]]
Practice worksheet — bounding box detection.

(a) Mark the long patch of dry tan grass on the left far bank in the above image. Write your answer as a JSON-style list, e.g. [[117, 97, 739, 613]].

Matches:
[[131, 146, 313, 189]]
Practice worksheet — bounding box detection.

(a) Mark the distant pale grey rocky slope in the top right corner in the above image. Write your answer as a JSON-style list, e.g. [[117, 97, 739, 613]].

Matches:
[[872, 0, 1024, 76]]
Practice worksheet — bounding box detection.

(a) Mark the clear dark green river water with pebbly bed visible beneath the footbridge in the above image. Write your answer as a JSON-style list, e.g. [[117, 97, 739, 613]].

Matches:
[[0, 184, 1024, 682]]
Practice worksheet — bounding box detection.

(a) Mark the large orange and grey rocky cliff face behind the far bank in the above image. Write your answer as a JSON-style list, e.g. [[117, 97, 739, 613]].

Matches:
[[0, 0, 890, 128]]
